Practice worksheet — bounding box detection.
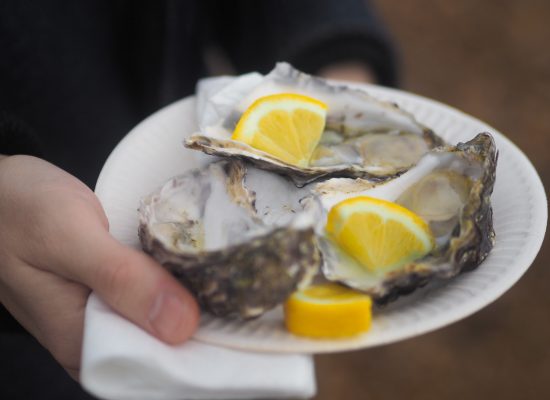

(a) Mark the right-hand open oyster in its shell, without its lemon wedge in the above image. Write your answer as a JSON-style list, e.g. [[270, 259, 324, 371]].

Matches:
[[315, 133, 497, 303]]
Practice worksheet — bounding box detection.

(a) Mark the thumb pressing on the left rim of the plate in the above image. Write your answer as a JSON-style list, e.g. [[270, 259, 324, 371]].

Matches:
[[62, 225, 199, 344]]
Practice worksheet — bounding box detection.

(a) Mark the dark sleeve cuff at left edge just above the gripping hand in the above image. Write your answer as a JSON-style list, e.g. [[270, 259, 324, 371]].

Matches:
[[0, 110, 42, 157]]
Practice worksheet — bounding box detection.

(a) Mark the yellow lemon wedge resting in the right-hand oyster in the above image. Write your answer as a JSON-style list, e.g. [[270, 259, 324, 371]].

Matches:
[[326, 196, 434, 272]]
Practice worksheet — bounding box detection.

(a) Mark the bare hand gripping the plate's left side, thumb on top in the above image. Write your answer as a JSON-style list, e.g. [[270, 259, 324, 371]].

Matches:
[[0, 156, 199, 379]]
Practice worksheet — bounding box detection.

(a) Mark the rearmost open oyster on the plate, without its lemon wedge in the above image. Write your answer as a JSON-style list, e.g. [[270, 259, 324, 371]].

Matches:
[[185, 63, 443, 186]]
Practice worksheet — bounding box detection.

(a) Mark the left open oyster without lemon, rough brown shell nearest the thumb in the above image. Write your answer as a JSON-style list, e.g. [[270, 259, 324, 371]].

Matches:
[[139, 160, 321, 319]]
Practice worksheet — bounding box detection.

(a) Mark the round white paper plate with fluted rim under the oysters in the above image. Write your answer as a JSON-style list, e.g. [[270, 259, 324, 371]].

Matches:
[[96, 85, 547, 353]]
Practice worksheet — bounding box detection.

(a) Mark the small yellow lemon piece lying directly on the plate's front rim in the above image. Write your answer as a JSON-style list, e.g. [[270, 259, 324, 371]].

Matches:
[[284, 283, 372, 338]]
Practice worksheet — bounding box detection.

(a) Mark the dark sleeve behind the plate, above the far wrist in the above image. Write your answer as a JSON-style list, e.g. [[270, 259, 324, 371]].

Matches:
[[205, 0, 397, 86]]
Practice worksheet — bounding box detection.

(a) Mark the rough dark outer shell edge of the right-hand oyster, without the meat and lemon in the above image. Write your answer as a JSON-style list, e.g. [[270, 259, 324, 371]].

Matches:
[[319, 133, 498, 303]]
